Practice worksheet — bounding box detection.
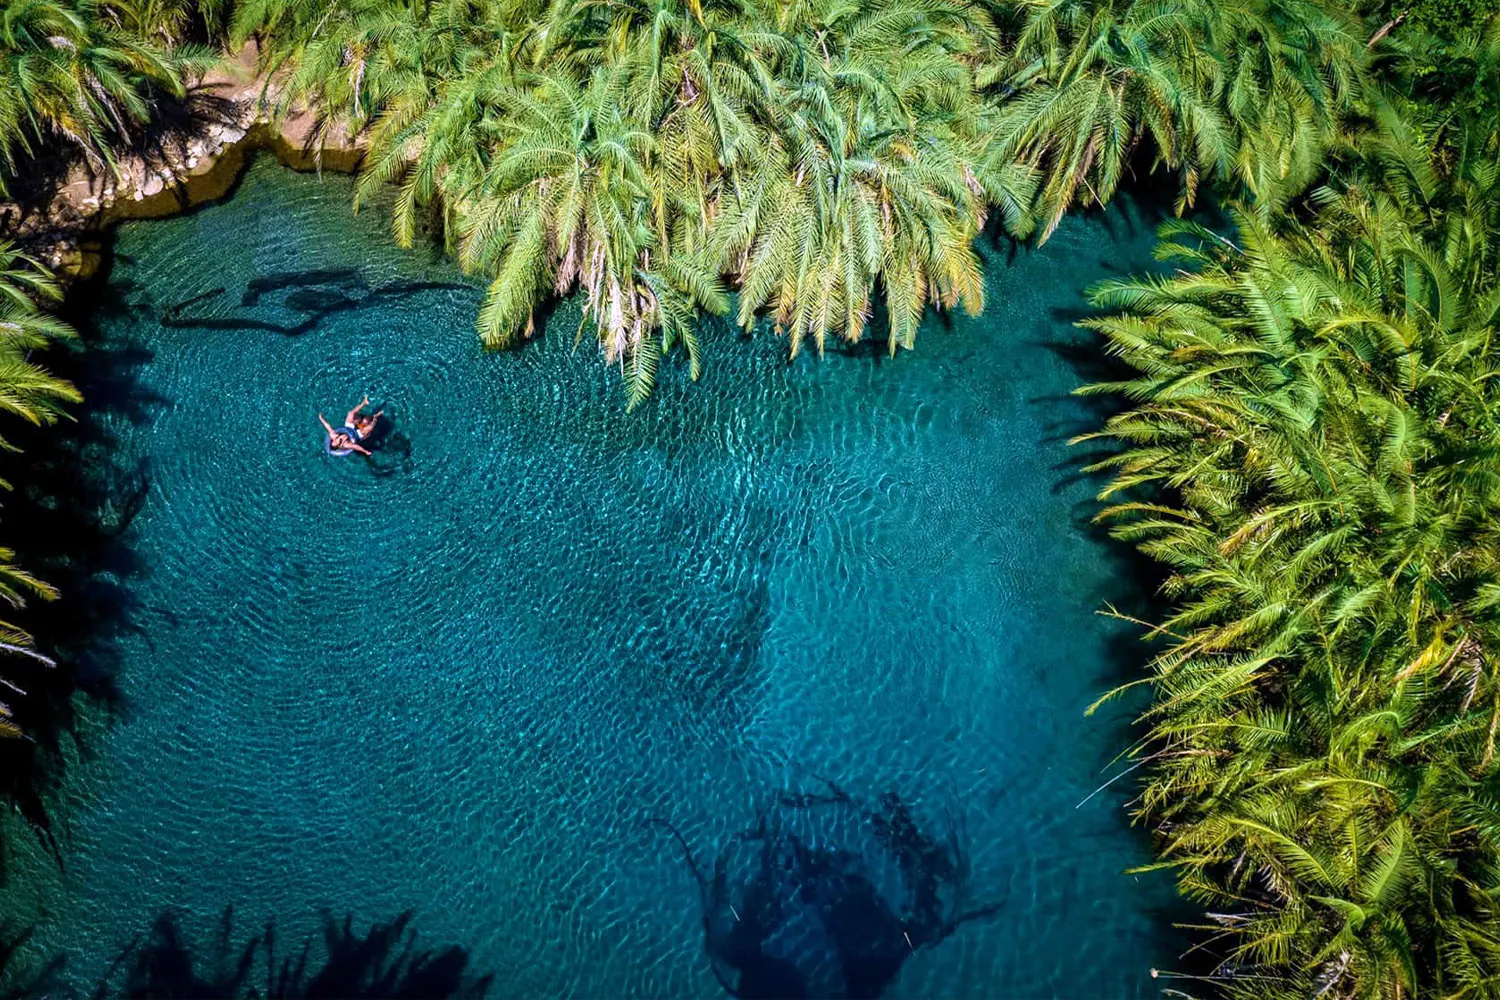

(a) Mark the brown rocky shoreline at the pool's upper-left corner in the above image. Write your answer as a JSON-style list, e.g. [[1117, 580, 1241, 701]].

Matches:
[[0, 42, 365, 279]]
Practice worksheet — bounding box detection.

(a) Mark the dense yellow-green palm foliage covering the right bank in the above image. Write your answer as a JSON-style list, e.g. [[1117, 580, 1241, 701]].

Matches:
[[1089, 13, 1500, 999]]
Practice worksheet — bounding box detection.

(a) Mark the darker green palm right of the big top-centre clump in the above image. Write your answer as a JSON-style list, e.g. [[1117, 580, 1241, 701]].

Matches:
[[981, 0, 1365, 238]]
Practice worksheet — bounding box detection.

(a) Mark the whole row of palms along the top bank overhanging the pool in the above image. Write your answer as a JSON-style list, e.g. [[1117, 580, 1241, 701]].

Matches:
[[234, 0, 1365, 399]]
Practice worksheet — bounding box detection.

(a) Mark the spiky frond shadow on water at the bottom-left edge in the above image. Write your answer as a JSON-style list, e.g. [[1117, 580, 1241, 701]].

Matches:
[[0, 909, 494, 1000]]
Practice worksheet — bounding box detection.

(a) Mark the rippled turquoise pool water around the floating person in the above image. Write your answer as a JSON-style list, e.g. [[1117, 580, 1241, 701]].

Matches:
[[11, 163, 1172, 999]]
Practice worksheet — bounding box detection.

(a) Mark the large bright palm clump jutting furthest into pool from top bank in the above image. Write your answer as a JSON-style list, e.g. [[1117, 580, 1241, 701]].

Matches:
[[236, 0, 1034, 402]]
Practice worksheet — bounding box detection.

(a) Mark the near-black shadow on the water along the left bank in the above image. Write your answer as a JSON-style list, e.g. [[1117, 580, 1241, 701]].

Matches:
[[0, 239, 168, 864]]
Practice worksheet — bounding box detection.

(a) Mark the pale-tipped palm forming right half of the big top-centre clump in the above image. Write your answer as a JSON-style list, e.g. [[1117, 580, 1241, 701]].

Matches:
[[713, 0, 1032, 354]]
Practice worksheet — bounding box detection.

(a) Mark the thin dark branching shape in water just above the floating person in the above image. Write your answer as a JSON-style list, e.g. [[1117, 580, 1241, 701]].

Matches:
[[161, 268, 473, 337]]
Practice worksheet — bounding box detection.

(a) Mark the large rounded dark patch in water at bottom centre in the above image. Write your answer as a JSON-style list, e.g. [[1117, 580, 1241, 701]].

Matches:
[[651, 780, 1004, 1000]]
